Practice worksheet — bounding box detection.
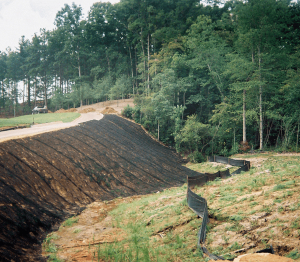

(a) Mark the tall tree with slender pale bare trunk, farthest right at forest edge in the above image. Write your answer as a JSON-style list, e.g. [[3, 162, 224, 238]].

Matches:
[[236, 0, 290, 150]]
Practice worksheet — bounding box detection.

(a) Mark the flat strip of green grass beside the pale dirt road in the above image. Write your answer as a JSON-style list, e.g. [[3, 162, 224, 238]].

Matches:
[[0, 113, 80, 127]]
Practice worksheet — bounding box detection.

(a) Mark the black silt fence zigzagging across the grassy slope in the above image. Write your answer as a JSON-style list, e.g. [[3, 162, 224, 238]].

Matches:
[[187, 156, 250, 260]]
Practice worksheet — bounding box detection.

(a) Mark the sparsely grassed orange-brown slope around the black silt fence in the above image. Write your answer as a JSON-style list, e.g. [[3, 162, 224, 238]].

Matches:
[[44, 153, 300, 262]]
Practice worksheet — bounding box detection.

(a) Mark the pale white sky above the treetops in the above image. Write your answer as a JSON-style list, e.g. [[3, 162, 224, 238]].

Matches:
[[0, 0, 119, 52]]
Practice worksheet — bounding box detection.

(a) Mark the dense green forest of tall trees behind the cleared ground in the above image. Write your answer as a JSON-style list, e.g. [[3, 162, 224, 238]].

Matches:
[[0, 0, 300, 161]]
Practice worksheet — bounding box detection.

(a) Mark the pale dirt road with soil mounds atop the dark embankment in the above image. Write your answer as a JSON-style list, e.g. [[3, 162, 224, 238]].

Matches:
[[0, 99, 133, 143]]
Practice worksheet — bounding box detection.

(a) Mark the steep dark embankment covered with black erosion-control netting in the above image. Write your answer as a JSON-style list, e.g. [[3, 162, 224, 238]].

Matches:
[[0, 115, 200, 261]]
